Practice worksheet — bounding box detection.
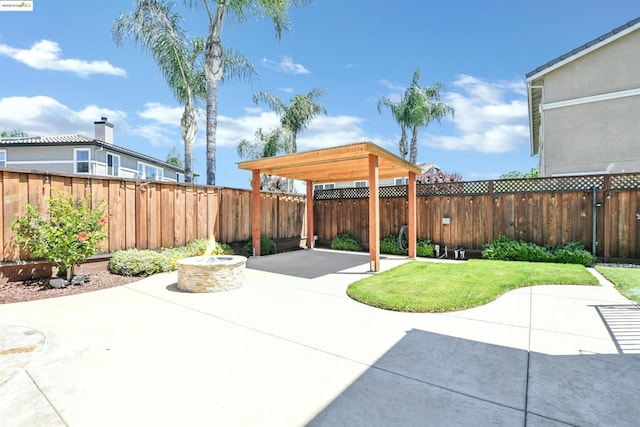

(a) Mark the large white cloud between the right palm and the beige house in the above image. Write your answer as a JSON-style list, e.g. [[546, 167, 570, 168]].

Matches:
[[427, 75, 529, 153]]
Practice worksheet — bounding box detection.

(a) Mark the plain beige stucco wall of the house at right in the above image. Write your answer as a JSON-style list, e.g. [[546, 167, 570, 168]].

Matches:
[[540, 31, 640, 176]]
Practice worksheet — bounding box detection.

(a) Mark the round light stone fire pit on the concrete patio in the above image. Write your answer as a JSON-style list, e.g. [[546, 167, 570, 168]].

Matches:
[[178, 255, 247, 292]]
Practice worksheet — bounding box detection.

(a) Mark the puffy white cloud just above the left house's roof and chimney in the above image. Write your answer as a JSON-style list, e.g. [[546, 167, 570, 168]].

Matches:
[[0, 96, 127, 136]]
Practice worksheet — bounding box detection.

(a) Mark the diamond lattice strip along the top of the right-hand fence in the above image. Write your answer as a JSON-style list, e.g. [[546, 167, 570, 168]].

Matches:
[[314, 174, 640, 200]]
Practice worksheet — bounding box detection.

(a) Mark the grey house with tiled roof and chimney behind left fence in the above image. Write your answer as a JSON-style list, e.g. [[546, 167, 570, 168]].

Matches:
[[0, 117, 184, 182]]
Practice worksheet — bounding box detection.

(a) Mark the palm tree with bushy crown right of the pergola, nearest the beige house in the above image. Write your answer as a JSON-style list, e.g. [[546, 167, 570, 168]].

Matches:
[[403, 69, 454, 164]]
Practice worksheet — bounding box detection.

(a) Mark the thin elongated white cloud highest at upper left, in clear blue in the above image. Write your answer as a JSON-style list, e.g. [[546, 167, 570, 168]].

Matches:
[[0, 40, 127, 77]]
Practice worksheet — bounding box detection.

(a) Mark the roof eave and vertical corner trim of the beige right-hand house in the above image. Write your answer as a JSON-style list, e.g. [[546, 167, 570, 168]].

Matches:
[[525, 17, 640, 155]]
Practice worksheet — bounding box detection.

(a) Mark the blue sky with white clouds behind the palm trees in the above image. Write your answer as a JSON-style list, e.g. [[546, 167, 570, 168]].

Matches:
[[0, 0, 640, 188]]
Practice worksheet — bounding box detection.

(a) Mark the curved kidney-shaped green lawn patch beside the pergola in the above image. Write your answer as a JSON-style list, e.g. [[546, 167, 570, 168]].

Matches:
[[347, 259, 598, 312]]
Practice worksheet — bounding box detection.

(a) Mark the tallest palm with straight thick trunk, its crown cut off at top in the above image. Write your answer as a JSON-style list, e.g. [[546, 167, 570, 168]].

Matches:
[[184, 0, 305, 185]]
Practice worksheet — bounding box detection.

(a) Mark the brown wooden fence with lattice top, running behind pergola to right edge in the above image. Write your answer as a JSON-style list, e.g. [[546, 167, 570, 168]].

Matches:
[[314, 174, 640, 260]]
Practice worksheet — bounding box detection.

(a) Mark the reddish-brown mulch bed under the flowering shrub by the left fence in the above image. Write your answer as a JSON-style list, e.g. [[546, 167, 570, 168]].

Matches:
[[0, 270, 141, 304]]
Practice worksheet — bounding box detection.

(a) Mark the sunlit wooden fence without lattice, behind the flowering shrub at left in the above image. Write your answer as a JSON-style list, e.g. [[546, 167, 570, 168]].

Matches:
[[0, 170, 306, 261]]
